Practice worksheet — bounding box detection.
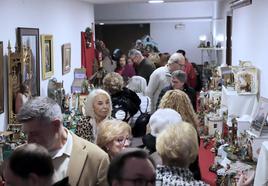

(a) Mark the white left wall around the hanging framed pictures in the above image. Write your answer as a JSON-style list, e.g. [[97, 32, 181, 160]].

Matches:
[[0, 0, 94, 131]]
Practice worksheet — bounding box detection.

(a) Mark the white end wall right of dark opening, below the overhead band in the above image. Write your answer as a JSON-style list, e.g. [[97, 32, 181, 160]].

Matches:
[[150, 21, 211, 64]]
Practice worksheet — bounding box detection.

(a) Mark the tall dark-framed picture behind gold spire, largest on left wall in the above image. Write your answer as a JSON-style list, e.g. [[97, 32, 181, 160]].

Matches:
[[17, 27, 40, 96]]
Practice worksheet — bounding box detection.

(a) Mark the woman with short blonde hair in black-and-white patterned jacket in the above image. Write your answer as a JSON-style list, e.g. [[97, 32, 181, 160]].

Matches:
[[156, 122, 207, 186]]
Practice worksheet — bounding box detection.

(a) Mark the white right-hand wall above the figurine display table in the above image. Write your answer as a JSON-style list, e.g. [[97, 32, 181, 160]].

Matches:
[[232, 0, 268, 98]]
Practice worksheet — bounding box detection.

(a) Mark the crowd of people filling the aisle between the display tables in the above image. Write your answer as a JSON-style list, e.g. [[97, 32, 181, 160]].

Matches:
[[0, 45, 253, 186]]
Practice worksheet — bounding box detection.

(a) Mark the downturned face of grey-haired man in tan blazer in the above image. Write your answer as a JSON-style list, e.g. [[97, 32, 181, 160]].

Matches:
[[23, 120, 57, 151]]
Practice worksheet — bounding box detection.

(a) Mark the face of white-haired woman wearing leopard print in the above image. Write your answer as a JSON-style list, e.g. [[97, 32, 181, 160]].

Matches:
[[93, 94, 110, 120]]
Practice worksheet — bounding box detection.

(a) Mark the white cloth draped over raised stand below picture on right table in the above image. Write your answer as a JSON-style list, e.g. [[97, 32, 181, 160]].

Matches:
[[221, 86, 258, 116]]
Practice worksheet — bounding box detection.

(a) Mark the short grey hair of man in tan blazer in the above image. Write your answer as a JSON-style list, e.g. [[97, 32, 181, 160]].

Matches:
[[17, 97, 63, 123]]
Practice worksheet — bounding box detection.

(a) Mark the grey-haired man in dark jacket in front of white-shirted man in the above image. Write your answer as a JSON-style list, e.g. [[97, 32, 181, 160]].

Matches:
[[157, 70, 196, 111]]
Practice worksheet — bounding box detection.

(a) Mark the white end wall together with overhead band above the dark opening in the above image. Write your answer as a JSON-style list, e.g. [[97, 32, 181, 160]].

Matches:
[[95, 1, 215, 63]]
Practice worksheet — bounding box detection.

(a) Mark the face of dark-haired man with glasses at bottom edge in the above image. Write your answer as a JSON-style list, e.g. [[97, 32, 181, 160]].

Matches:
[[112, 157, 155, 186]]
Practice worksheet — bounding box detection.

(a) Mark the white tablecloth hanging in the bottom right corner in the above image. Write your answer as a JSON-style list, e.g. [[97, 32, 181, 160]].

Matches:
[[254, 141, 268, 186]]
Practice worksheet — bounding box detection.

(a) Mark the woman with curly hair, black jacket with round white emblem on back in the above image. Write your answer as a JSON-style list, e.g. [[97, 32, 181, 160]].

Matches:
[[103, 72, 141, 122]]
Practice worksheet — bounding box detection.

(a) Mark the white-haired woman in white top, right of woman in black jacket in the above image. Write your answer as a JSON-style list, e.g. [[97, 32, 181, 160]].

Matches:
[[127, 76, 151, 126]]
